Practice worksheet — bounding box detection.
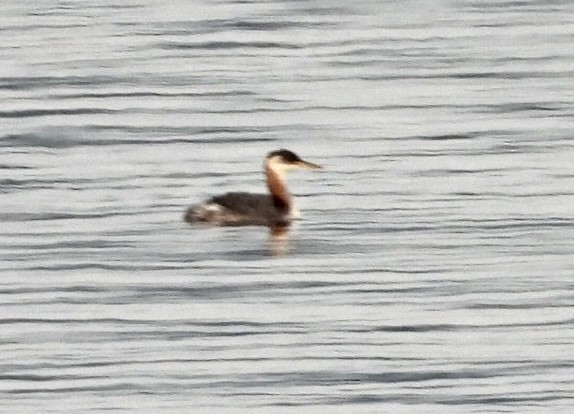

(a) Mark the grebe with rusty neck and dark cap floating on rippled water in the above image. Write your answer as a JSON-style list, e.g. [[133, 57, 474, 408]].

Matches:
[[185, 149, 321, 231]]
